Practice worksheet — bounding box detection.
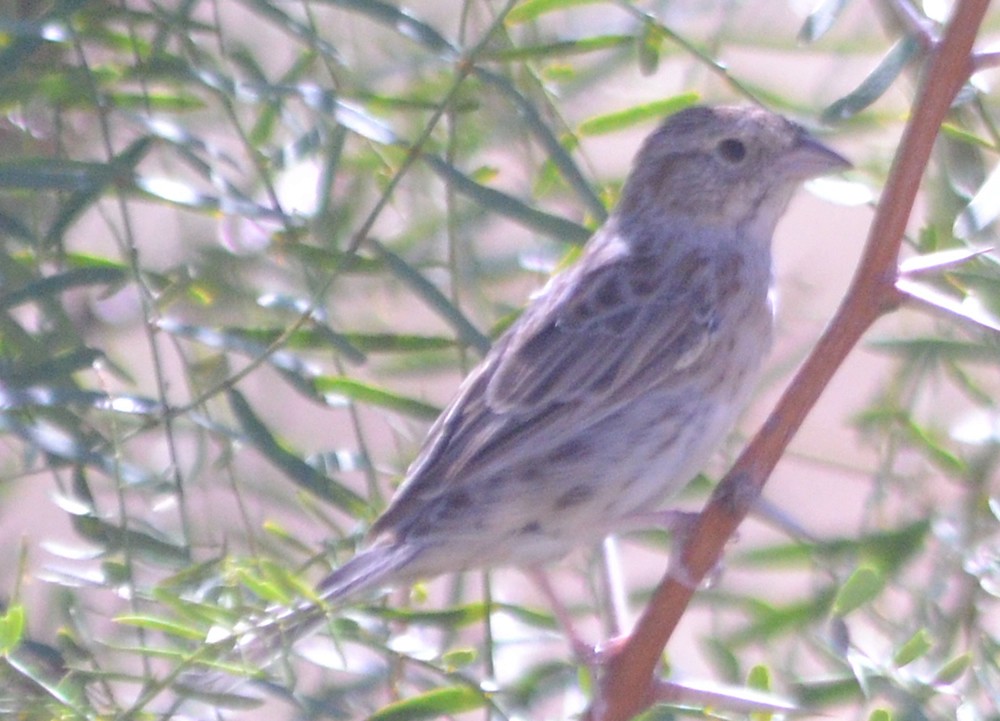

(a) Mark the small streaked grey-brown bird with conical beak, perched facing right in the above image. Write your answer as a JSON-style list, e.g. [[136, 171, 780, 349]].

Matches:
[[207, 105, 850, 668]]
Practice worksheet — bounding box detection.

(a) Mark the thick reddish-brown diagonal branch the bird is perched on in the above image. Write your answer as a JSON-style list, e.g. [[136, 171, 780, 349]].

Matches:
[[587, 0, 989, 721]]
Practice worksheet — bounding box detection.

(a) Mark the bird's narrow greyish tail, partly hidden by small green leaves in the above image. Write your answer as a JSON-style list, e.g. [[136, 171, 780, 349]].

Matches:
[[178, 544, 420, 694]]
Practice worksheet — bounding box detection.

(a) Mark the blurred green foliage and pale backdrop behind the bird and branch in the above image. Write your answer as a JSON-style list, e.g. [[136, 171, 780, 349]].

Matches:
[[0, 0, 1000, 719]]
